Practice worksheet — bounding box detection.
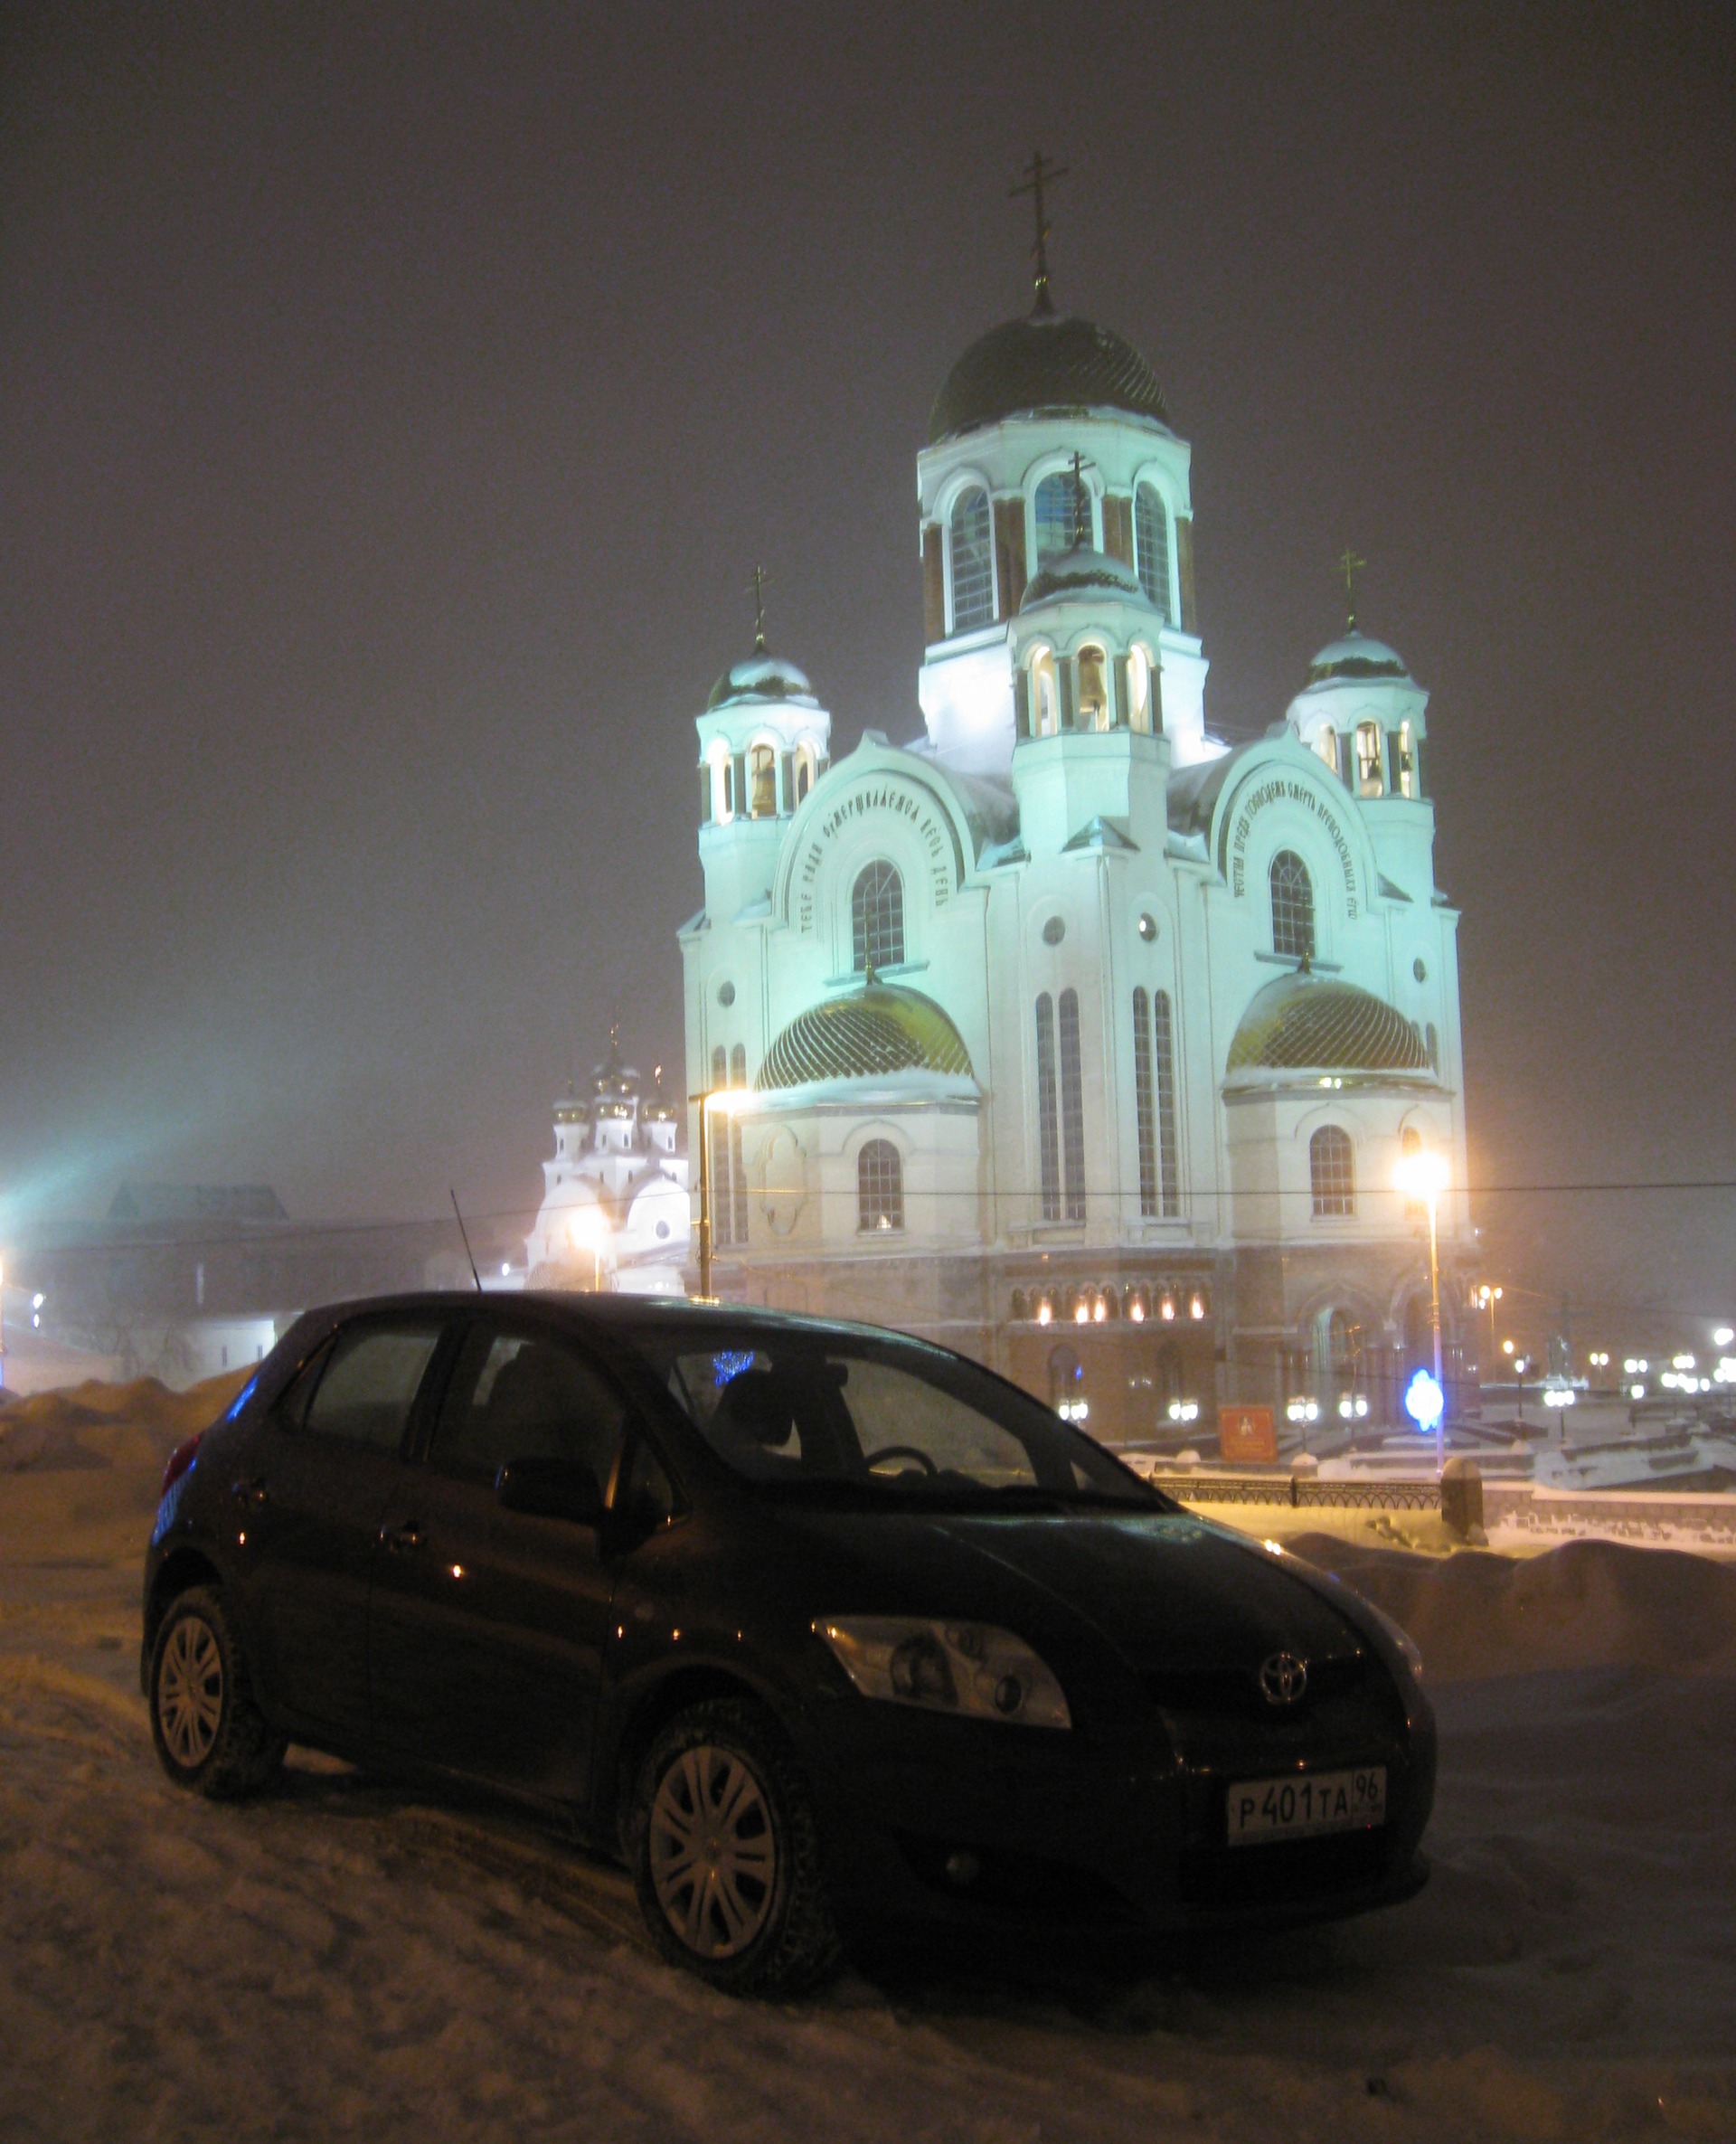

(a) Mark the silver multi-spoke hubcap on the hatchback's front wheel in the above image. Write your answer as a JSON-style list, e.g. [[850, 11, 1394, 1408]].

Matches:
[[649, 1743, 778, 1958]]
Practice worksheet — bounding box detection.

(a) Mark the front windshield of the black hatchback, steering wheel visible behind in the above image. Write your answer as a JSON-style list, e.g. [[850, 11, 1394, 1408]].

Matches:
[[635, 1329, 1165, 1509]]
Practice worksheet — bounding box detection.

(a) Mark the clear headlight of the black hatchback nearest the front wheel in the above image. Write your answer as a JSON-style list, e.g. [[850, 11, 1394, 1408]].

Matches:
[[815, 1614, 1074, 1728]]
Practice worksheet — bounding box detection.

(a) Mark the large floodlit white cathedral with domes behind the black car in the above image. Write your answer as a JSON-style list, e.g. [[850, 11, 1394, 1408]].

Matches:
[[679, 217, 1468, 1439]]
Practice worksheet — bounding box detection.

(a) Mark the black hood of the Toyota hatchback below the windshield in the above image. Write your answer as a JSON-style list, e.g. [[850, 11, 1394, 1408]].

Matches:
[[776, 1512, 1363, 1675]]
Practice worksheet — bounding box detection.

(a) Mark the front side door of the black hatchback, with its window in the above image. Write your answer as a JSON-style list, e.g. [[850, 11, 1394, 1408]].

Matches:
[[369, 1314, 628, 1801]]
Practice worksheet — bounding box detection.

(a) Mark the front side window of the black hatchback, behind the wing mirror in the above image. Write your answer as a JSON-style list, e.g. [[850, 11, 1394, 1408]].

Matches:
[[429, 1321, 626, 1495]]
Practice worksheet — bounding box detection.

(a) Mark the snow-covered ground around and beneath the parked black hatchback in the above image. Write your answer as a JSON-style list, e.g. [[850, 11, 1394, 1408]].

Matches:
[[0, 1389, 1736, 2144]]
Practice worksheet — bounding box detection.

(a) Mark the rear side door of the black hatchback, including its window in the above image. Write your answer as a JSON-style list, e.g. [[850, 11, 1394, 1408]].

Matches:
[[231, 1312, 444, 1750]]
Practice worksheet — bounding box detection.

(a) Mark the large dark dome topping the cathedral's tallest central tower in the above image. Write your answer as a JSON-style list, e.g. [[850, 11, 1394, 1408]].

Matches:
[[928, 313, 1170, 446]]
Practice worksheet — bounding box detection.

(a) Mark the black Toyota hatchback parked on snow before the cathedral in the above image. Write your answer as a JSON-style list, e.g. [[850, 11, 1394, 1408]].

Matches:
[[141, 1295, 1434, 1992]]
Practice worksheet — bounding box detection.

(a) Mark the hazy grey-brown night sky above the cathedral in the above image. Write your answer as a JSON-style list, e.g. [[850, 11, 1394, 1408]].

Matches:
[[0, 0, 1736, 1340]]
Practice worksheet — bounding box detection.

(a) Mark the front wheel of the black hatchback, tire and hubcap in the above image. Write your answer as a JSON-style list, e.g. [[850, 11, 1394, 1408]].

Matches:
[[626, 1698, 843, 1996]]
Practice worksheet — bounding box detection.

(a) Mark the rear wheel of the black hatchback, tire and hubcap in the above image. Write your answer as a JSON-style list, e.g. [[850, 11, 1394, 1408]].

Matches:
[[150, 1587, 285, 1801]]
